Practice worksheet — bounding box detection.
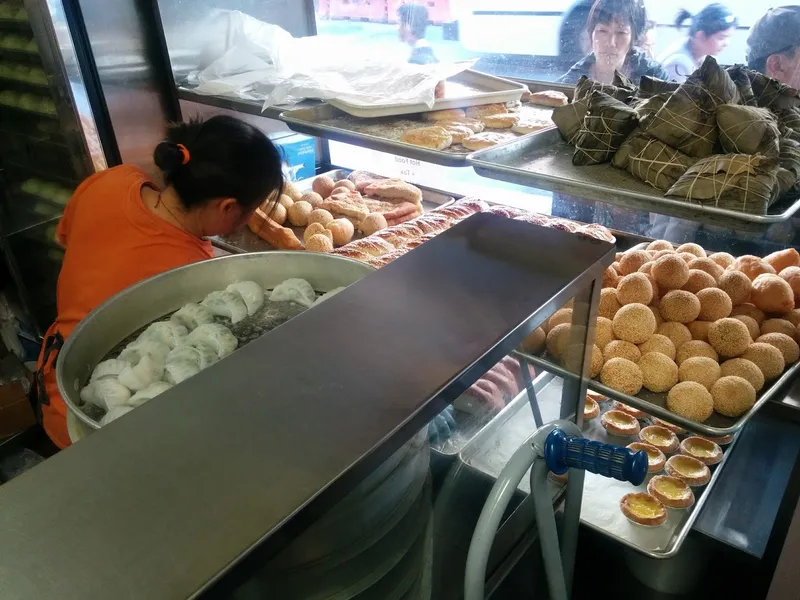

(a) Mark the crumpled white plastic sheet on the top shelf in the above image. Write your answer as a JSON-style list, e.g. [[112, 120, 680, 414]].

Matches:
[[190, 11, 474, 108]]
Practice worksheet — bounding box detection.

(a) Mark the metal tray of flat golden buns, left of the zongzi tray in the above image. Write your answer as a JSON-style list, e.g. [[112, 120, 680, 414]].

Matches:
[[280, 92, 555, 167]]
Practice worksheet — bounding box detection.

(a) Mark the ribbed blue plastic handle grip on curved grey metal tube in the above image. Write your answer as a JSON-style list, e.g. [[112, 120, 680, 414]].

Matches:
[[544, 429, 648, 485]]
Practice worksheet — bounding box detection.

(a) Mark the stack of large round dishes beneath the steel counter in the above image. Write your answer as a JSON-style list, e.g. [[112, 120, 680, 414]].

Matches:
[[236, 431, 432, 600]]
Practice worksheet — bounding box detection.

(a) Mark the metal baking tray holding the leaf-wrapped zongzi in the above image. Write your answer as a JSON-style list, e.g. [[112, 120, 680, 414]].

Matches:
[[468, 129, 800, 228]]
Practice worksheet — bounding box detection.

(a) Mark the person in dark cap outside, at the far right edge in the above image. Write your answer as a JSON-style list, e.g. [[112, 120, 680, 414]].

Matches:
[[747, 5, 800, 89]]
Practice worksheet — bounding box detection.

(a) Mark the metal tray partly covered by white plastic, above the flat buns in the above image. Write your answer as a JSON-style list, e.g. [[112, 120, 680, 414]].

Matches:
[[328, 70, 525, 119]]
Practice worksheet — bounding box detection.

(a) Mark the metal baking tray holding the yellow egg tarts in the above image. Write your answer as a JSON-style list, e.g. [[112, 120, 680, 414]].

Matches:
[[461, 377, 736, 559]]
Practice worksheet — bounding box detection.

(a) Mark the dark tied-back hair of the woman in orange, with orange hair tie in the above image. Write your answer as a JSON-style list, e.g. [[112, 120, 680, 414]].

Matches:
[[153, 116, 283, 209]]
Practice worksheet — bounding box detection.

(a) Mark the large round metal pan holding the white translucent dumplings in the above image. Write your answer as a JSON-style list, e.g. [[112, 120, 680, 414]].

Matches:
[[56, 252, 375, 442]]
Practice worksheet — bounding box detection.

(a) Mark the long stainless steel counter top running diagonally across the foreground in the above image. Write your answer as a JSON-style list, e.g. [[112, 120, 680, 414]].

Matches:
[[0, 214, 614, 600]]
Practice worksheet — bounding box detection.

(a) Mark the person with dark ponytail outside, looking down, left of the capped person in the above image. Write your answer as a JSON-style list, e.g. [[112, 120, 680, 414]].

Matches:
[[659, 4, 738, 82]]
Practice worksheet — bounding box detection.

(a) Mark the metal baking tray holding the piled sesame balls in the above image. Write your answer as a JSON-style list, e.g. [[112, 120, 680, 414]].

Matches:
[[515, 351, 800, 437]]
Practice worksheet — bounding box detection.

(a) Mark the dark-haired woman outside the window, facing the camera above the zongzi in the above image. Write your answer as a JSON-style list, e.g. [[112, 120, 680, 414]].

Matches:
[[558, 0, 668, 83]]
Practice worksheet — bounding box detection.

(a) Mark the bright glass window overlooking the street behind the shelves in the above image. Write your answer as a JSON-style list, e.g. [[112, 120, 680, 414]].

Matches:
[[310, 0, 765, 81]]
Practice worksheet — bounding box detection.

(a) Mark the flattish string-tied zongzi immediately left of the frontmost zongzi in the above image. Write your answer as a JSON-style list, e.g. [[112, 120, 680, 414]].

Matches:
[[613, 131, 695, 191]]
